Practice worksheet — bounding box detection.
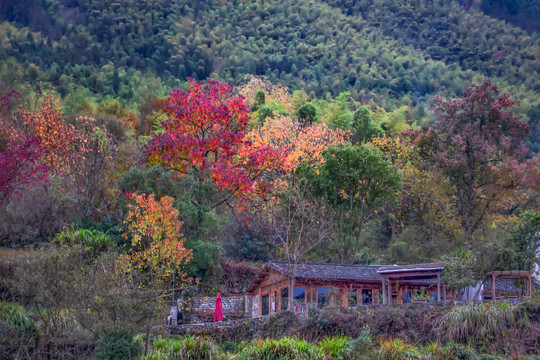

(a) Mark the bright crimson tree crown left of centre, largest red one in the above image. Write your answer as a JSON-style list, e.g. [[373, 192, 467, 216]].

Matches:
[[147, 79, 285, 207]]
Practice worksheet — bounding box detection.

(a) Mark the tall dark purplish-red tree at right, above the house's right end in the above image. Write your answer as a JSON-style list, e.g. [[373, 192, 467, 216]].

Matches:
[[404, 79, 529, 243]]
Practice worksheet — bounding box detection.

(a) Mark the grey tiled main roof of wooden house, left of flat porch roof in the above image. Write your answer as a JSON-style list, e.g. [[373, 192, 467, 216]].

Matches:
[[268, 262, 386, 281]]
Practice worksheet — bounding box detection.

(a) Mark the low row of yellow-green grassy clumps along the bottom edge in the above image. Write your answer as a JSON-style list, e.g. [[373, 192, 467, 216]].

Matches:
[[142, 334, 506, 360]]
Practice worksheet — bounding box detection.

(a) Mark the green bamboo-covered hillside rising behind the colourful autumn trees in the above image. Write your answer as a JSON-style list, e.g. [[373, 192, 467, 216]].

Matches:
[[0, 0, 540, 152]]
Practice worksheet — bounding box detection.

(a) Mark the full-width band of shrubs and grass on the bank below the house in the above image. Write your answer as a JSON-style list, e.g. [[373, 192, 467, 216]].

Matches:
[[4, 299, 540, 360]]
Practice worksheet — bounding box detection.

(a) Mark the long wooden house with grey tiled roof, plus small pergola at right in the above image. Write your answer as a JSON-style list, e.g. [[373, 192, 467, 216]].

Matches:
[[245, 262, 533, 317]]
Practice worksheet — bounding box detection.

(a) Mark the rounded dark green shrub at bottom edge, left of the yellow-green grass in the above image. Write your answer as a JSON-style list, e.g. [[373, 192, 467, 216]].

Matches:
[[94, 333, 141, 360]]
